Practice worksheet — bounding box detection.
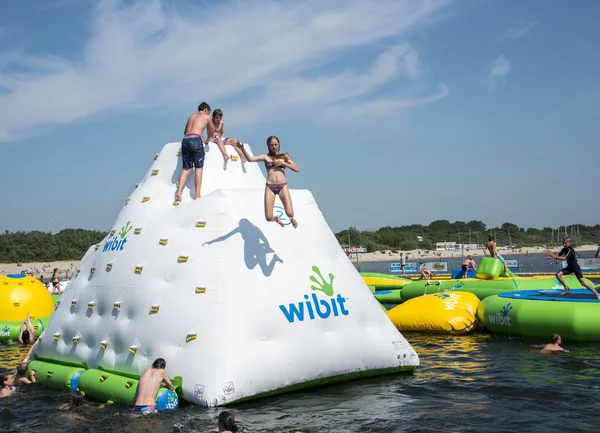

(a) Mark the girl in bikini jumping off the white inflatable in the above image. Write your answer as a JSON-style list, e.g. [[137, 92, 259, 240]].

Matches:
[[238, 135, 299, 228]]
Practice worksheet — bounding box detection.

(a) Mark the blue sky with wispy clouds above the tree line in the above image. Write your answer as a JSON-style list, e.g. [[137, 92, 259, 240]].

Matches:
[[0, 0, 600, 232]]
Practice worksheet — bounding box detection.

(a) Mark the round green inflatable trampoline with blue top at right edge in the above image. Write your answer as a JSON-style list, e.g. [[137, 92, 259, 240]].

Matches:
[[477, 287, 600, 341]]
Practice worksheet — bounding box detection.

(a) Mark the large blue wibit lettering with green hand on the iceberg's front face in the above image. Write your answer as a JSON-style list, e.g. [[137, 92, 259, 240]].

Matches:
[[279, 266, 349, 323]]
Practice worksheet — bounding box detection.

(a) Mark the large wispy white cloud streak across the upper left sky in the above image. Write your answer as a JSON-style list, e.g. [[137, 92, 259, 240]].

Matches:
[[0, 0, 450, 141]]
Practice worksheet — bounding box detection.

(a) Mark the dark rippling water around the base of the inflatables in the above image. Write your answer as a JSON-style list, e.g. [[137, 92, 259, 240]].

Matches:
[[0, 251, 600, 433]]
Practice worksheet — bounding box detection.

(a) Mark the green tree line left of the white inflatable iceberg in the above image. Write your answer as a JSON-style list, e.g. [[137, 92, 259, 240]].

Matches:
[[0, 229, 107, 263]]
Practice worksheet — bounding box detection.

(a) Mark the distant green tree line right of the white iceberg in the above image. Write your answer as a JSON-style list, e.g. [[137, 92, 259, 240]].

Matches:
[[335, 220, 600, 252]]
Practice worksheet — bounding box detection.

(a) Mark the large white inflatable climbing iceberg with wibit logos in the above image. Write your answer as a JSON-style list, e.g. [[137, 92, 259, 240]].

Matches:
[[35, 139, 419, 406]]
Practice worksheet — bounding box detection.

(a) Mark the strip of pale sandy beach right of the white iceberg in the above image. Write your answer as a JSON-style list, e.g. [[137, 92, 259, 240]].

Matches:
[[350, 245, 598, 262]]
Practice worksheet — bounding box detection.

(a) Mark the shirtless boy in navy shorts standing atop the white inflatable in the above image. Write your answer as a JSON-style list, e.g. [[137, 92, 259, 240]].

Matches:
[[175, 102, 214, 202]]
